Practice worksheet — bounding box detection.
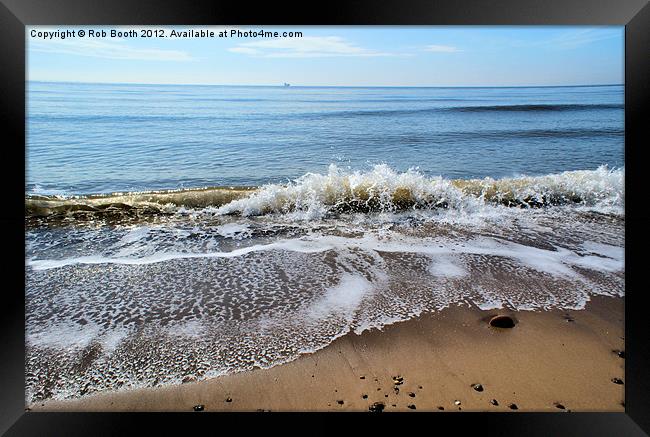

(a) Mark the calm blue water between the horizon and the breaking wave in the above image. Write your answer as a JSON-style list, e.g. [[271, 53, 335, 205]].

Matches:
[[27, 82, 624, 193]]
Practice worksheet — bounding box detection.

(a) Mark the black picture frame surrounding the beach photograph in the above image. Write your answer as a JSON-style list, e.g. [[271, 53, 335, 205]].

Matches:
[[0, 0, 650, 436]]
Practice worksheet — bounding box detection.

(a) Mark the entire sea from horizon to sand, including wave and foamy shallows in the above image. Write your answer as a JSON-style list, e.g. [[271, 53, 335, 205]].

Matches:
[[25, 81, 625, 404]]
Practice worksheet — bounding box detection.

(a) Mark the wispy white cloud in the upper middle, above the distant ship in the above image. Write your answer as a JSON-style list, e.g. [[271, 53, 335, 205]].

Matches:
[[228, 36, 396, 58]]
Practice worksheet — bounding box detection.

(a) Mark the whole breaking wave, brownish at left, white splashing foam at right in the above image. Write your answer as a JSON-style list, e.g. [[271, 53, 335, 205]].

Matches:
[[25, 164, 624, 223]]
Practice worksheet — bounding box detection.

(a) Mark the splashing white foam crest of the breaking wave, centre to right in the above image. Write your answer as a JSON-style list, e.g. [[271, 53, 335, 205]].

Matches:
[[216, 164, 624, 220]]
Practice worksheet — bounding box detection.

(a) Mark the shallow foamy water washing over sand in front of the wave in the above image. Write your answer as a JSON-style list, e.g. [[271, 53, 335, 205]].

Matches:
[[26, 201, 624, 402]]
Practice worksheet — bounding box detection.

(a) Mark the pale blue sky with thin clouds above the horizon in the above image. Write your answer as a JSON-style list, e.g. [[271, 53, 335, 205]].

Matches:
[[26, 26, 624, 86]]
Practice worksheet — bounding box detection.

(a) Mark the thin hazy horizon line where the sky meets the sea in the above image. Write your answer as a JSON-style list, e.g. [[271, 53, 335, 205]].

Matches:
[[25, 79, 625, 88]]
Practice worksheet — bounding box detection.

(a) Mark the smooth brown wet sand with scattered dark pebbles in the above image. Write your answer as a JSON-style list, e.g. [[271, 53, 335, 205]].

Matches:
[[30, 297, 625, 412]]
